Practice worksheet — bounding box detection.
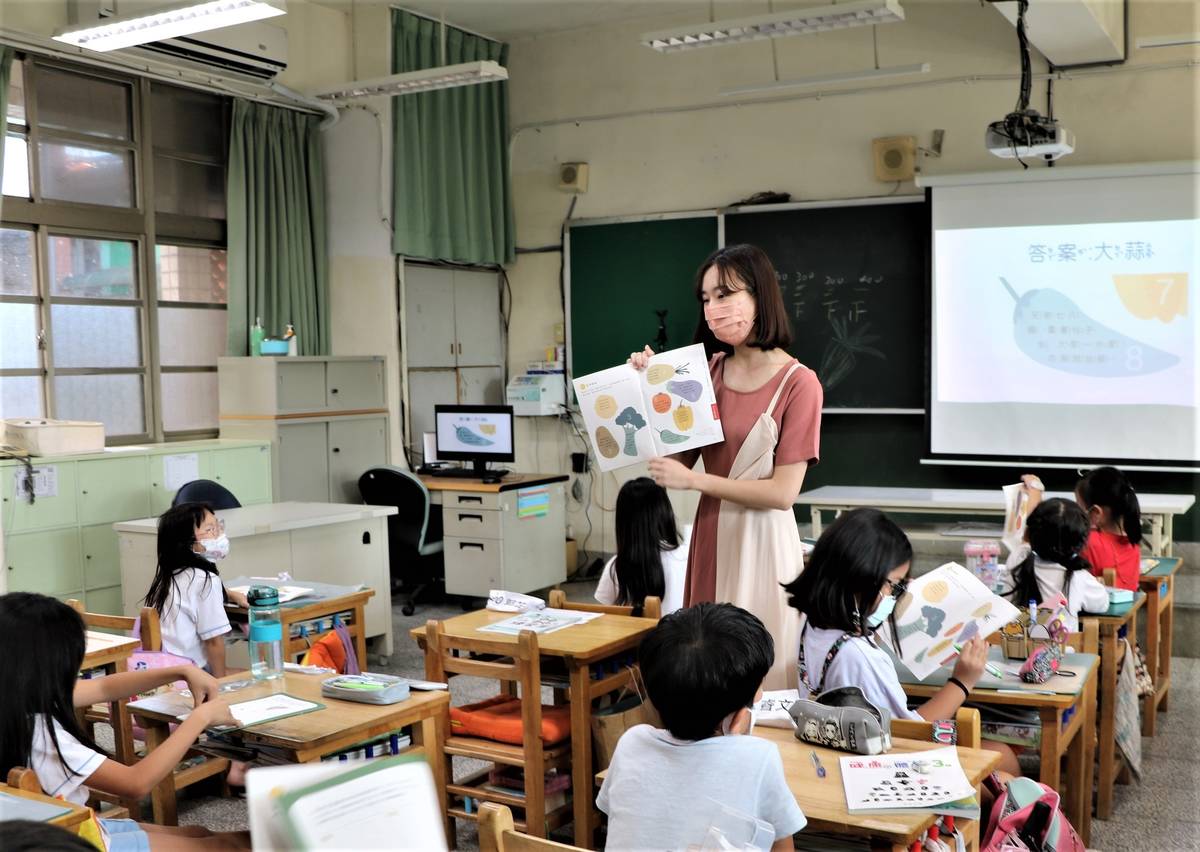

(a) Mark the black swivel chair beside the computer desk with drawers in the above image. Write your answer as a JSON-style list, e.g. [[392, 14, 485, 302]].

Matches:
[[359, 466, 445, 616]]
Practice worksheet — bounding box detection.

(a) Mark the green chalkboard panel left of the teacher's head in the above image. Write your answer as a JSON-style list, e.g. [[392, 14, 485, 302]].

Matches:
[[566, 215, 716, 376]]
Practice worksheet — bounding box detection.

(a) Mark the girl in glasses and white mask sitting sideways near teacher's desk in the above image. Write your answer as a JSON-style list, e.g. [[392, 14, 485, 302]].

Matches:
[[145, 503, 246, 678]]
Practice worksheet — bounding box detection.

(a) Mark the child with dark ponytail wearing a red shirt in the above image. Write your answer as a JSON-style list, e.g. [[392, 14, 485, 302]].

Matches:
[[1075, 467, 1141, 592]]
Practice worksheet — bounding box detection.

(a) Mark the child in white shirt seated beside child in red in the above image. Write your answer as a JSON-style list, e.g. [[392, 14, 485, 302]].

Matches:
[[998, 498, 1109, 632]]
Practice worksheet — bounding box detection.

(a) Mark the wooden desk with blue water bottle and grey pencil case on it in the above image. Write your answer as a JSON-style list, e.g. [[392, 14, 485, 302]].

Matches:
[[130, 672, 452, 842]]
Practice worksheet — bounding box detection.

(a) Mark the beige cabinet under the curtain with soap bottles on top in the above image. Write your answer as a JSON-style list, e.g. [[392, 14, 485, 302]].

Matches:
[[217, 356, 389, 503]]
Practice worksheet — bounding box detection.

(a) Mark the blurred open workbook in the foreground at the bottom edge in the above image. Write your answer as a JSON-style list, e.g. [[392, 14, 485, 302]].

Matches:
[[246, 756, 446, 852]]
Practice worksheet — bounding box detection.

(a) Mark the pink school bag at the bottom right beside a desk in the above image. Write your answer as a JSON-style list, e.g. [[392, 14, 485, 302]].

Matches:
[[980, 775, 1087, 852]]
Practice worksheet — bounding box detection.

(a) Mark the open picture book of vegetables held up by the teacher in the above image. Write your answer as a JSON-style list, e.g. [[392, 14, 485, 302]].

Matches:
[[572, 343, 725, 470]]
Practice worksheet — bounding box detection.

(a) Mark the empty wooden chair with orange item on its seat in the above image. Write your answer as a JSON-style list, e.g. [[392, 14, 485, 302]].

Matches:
[[425, 620, 573, 838]]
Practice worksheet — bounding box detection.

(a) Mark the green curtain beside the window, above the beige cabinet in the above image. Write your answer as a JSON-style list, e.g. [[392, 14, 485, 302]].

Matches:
[[226, 98, 330, 355]]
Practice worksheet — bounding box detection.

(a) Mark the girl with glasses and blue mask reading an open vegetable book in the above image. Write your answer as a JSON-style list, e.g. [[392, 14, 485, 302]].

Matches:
[[785, 509, 1020, 775]]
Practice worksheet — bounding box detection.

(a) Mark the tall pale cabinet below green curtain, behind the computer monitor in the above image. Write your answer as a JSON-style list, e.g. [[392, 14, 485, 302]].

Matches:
[[404, 264, 504, 458]]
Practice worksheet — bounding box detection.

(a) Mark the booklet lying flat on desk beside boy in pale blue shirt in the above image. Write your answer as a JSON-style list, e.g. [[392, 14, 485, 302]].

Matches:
[[839, 745, 979, 820]]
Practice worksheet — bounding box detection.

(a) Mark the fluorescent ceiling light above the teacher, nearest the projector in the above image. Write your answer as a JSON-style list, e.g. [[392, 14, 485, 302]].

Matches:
[[642, 0, 904, 53]]
